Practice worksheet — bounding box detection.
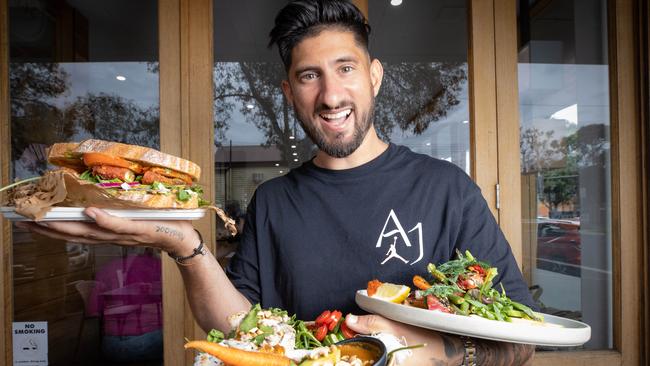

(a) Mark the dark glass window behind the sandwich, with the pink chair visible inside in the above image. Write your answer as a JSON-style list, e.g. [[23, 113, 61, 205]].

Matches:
[[9, 0, 163, 365]]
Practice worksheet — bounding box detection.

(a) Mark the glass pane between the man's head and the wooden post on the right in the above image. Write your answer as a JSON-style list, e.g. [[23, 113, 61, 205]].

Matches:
[[368, 0, 470, 174]]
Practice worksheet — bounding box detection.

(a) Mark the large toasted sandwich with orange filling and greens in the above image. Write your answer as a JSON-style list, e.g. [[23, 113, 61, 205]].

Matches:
[[47, 139, 209, 209]]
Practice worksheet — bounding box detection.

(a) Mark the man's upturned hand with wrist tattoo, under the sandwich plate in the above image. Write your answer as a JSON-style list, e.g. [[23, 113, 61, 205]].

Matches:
[[16, 207, 199, 256]]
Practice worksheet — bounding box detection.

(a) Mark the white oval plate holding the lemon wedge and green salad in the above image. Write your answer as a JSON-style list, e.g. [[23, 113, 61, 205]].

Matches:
[[355, 290, 591, 347]]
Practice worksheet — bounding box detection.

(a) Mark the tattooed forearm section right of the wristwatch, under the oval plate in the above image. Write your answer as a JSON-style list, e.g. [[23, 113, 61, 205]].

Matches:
[[475, 340, 535, 366]]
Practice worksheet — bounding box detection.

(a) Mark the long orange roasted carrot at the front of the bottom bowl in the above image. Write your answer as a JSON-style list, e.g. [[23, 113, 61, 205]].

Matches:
[[185, 341, 291, 366]]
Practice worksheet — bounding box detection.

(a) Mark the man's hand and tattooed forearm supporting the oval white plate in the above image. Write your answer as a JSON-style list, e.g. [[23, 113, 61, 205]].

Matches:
[[345, 314, 535, 366]]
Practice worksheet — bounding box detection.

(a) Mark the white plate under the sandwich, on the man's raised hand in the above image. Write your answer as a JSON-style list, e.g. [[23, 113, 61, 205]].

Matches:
[[0, 207, 205, 221]]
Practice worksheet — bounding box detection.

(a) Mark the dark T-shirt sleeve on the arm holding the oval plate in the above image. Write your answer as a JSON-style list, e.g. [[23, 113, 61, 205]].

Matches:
[[453, 174, 537, 309]]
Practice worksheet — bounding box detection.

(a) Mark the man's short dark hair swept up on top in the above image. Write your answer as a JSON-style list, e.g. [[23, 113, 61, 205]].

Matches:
[[269, 0, 370, 71]]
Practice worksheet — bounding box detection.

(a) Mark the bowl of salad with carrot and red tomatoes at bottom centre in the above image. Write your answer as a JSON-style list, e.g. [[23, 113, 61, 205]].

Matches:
[[185, 304, 392, 366]]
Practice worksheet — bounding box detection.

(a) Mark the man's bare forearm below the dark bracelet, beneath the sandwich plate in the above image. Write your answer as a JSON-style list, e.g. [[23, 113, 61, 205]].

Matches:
[[178, 247, 251, 332]]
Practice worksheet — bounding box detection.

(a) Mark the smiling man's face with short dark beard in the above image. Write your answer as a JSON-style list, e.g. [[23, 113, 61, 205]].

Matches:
[[282, 30, 383, 158]]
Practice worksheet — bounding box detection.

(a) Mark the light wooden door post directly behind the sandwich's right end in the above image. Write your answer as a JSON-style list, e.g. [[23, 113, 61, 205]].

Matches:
[[159, 0, 216, 365]]
